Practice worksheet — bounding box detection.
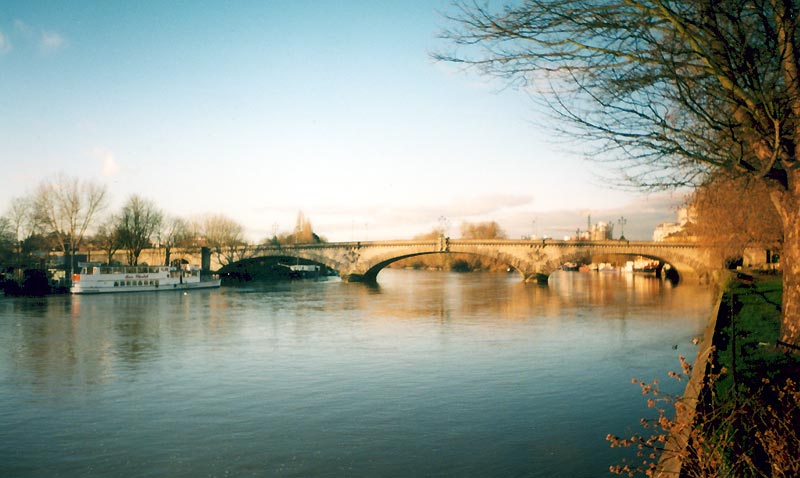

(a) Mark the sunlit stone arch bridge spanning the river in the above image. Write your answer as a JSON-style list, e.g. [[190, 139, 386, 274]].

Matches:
[[220, 237, 720, 282]]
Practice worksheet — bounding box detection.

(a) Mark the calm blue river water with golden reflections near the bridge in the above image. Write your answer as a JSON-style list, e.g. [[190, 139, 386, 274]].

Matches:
[[0, 270, 712, 477]]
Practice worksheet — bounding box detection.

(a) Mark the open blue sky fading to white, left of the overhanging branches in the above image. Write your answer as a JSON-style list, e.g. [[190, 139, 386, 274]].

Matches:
[[0, 0, 679, 241]]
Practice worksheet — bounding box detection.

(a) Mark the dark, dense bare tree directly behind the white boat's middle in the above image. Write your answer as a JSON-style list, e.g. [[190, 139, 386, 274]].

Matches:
[[119, 194, 164, 266]]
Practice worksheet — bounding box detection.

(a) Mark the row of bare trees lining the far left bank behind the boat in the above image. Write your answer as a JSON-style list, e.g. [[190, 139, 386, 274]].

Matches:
[[0, 174, 324, 290]]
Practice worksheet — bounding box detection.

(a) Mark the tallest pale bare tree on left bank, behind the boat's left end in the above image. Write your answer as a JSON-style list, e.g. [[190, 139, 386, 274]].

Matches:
[[33, 175, 106, 282]]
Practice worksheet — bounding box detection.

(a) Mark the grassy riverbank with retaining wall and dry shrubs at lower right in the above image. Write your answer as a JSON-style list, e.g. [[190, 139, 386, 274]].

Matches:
[[656, 275, 800, 477]]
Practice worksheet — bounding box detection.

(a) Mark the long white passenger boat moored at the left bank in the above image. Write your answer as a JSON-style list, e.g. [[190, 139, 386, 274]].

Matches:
[[70, 264, 220, 294]]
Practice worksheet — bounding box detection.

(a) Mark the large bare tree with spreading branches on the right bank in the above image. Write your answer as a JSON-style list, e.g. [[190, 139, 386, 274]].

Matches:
[[435, 0, 800, 347]]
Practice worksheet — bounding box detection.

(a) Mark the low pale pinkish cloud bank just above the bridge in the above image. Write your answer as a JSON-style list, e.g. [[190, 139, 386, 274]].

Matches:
[[242, 193, 683, 241]]
